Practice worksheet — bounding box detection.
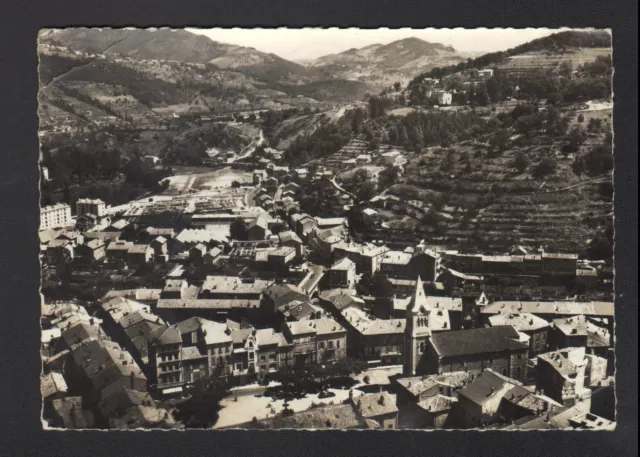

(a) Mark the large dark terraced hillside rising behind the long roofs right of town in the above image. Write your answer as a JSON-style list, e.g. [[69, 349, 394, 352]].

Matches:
[[379, 126, 613, 252]]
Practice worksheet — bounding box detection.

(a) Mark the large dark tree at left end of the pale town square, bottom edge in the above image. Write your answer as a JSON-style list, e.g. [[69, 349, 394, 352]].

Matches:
[[173, 367, 229, 428]]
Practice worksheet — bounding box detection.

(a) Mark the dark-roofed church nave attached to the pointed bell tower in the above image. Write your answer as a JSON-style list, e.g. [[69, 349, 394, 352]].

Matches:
[[417, 326, 529, 381]]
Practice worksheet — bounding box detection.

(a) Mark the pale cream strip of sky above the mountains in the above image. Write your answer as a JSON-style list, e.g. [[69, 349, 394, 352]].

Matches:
[[187, 28, 580, 61]]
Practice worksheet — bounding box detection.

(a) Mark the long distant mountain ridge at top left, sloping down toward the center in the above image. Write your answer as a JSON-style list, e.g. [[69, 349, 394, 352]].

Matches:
[[40, 28, 308, 81]]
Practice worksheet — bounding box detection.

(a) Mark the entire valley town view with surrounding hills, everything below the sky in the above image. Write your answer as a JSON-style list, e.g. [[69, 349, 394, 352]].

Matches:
[[38, 28, 616, 430]]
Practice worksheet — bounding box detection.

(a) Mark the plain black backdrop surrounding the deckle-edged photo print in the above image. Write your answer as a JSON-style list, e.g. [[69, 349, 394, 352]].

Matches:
[[0, 0, 638, 456]]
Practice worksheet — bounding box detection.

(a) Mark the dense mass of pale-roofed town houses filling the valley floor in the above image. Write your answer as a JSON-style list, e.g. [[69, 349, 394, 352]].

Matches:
[[40, 164, 615, 429]]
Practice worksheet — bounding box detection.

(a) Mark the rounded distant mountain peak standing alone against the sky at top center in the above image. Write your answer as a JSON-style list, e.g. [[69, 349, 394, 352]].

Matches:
[[306, 38, 469, 84]]
